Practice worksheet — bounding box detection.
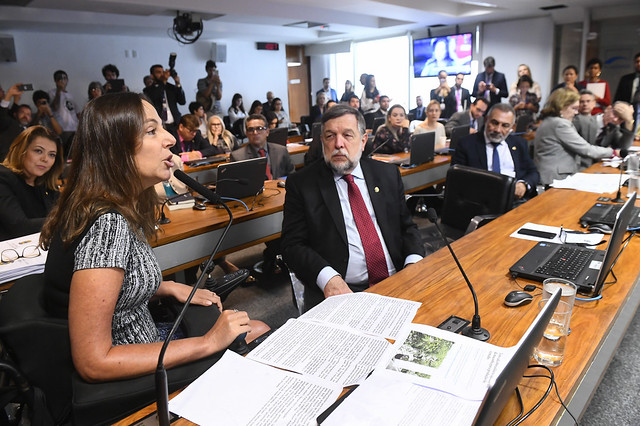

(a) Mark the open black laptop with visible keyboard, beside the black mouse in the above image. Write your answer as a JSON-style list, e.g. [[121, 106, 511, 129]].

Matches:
[[509, 192, 636, 296]]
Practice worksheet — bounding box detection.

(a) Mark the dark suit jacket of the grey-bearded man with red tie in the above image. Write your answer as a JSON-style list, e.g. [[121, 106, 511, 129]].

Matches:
[[282, 158, 424, 309]]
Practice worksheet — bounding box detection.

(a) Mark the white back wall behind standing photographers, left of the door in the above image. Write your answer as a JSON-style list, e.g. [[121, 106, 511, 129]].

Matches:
[[0, 32, 288, 113]]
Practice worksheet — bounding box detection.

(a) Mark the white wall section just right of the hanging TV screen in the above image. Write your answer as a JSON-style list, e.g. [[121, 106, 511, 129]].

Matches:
[[480, 17, 554, 104]]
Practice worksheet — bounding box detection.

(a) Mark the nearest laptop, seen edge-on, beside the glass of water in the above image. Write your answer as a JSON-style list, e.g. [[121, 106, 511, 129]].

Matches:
[[473, 290, 562, 426]]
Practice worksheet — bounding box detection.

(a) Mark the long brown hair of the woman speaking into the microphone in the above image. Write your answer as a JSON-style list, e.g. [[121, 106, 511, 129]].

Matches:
[[40, 92, 158, 248]]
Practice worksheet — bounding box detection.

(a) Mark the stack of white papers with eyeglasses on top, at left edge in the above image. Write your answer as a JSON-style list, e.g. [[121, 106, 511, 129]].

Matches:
[[0, 232, 47, 283]]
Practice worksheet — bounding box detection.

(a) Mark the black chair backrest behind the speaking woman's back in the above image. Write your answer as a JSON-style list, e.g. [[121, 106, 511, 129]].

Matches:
[[0, 274, 73, 421]]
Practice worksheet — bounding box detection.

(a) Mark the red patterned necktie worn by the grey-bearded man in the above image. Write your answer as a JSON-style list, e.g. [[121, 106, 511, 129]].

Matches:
[[342, 175, 389, 286]]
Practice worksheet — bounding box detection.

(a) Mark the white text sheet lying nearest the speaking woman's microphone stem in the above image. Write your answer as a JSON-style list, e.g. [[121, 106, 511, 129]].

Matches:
[[169, 351, 342, 426]]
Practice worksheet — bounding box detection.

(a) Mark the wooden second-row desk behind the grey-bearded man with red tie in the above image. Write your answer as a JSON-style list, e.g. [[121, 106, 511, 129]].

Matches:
[[152, 154, 451, 275]]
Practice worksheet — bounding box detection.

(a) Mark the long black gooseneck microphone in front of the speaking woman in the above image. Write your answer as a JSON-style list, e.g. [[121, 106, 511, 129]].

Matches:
[[155, 170, 233, 426]]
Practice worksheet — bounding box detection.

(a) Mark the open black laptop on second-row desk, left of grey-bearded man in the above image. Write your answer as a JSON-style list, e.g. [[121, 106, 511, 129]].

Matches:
[[216, 157, 267, 198]]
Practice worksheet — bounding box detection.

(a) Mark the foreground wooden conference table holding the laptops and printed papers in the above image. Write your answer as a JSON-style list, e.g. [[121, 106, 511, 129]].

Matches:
[[130, 161, 640, 425]]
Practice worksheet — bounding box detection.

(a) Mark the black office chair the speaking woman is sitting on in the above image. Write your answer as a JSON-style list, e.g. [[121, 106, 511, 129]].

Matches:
[[0, 274, 221, 425]]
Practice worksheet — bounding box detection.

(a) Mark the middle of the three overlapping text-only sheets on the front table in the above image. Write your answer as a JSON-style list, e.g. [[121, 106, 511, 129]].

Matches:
[[247, 319, 391, 386]]
